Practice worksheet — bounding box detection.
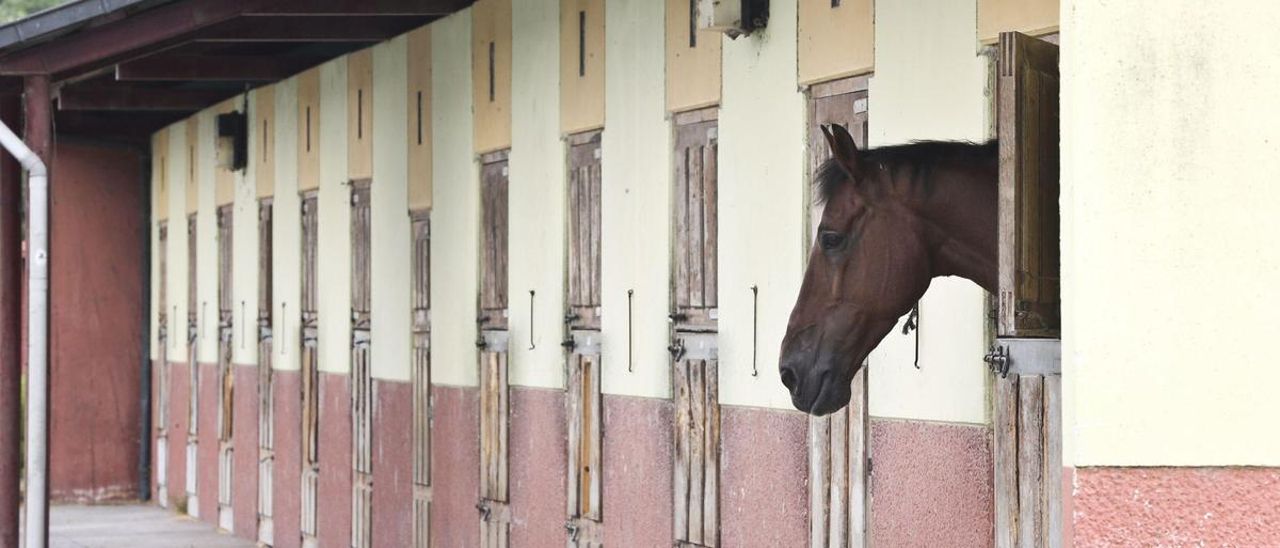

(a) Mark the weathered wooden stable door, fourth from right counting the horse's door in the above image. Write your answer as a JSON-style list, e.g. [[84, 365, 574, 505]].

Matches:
[[564, 131, 603, 548]]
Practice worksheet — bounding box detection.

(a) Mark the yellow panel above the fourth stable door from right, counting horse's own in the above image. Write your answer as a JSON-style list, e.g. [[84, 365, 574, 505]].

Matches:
[[559, 0, 605, 133]]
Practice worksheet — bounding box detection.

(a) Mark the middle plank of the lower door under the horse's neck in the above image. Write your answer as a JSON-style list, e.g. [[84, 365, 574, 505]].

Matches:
[[1018, 375, 1044, 548]]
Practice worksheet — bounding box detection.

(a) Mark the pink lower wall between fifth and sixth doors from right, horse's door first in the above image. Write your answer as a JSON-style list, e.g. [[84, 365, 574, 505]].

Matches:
[[431, 385, 480, 548]]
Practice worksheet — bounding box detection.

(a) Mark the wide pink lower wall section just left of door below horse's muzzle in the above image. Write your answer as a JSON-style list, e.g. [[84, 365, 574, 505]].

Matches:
[[719, 406, 809, 547]]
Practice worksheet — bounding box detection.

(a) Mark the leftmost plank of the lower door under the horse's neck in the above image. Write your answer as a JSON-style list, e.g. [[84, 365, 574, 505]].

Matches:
[[992, 376, 1019, 548]]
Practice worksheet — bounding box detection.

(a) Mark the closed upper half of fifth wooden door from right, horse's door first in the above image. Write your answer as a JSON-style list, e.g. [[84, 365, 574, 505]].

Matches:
[[480, 155, 509, 330]]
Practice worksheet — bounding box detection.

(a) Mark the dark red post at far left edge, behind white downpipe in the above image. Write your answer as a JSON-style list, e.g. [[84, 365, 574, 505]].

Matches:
[[0, 96, 22, 547]]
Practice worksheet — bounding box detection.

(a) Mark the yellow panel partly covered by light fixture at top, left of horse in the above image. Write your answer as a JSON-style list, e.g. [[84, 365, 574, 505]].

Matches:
[[667, 0, 722, 113]]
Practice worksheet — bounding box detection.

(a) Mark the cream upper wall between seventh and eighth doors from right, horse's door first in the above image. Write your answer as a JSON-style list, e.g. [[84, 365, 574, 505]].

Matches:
[[316, 58, 351, 373]]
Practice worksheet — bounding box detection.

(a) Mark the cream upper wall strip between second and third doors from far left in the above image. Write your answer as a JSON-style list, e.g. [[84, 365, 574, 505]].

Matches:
[[193, 109, 218, 364]]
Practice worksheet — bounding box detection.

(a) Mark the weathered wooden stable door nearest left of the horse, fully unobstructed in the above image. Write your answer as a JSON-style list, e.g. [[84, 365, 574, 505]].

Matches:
[[668, 110, 721, 547]]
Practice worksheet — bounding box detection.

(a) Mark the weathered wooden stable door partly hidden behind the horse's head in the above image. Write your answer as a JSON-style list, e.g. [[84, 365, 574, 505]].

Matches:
[[804, 77, 870, 548]]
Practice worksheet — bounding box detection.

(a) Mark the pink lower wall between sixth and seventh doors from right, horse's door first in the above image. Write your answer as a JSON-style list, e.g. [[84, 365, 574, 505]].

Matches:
[[372, 380, 413, 547]]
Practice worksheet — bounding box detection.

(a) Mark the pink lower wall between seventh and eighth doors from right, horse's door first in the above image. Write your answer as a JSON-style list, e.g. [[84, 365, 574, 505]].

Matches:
[[316, 373, 352, 547]]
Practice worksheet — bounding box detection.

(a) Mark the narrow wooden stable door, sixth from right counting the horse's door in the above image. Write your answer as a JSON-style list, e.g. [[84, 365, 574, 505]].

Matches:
[[410, 211, 431, 548]]
